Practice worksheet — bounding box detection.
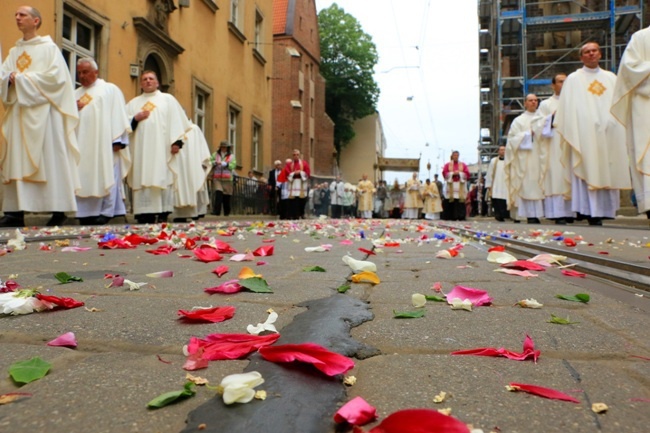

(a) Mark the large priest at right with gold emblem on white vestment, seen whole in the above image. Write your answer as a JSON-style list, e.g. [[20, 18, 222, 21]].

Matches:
[[555, 42, 631, 225]]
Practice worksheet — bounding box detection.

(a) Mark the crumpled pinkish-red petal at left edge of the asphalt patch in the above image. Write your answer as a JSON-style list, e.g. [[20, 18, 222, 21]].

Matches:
[[187, 334, 280, 361]]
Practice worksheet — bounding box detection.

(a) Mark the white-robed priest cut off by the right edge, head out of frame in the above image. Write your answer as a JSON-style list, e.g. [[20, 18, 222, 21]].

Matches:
[[611, 28, 650, 218]]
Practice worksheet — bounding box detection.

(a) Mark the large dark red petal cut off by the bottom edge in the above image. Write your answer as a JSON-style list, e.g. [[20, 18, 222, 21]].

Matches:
[[368, 409, 469, 433]]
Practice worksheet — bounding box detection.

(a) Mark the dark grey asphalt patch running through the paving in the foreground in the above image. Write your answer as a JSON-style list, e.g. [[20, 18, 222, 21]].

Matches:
[[182, 294, 379, 433]]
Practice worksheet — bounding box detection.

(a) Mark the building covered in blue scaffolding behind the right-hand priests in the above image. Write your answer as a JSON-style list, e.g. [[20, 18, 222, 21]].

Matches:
[[478, 0, 650, 163]]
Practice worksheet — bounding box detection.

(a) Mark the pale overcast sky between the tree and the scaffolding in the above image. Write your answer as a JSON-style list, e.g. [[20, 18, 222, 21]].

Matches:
[[316, 0, 479, 182]]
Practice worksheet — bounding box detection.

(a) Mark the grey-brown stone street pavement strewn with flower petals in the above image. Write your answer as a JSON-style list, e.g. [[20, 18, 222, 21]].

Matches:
[[0, 219, 650, 433]]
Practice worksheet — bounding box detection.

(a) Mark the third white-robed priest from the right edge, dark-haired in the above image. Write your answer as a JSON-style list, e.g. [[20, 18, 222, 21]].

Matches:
[[533, 73, 575, 224]]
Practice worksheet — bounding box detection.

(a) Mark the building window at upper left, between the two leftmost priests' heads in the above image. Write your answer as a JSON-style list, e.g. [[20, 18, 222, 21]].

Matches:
[[61, 10, 101, 85]]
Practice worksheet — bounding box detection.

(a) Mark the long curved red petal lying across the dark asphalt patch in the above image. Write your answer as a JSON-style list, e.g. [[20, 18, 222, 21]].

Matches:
[[260, 343, 354, 376]]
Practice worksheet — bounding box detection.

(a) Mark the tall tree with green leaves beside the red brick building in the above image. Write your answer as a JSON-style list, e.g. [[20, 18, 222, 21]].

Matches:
[[318, 3, 379, 161]]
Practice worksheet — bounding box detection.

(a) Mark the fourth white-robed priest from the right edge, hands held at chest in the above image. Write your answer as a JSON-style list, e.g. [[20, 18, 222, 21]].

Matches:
[[505, 93, 544, 224]]
